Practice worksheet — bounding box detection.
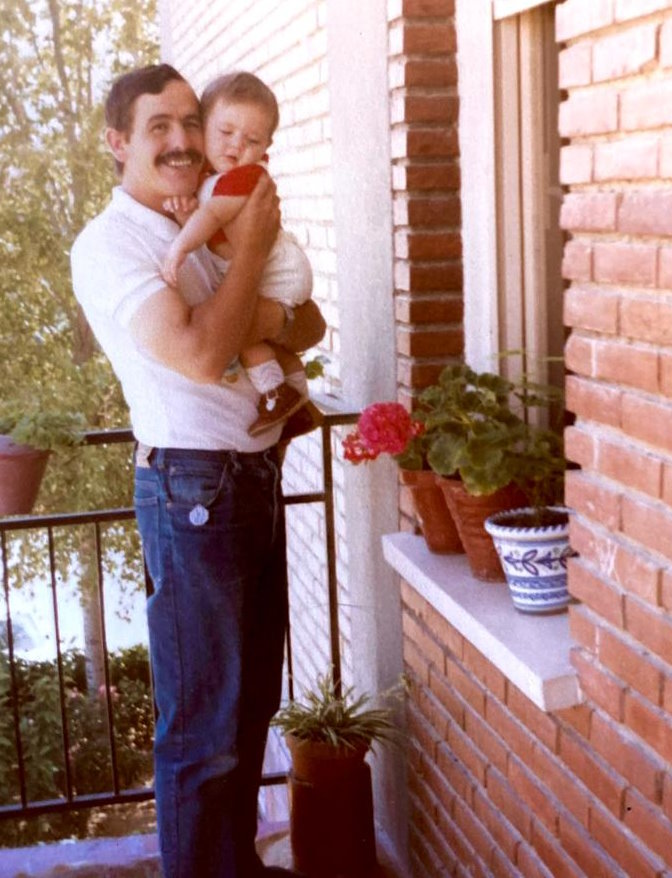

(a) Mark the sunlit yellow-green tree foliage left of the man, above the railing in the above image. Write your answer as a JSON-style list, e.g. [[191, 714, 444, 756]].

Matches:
[[0, 0, 158, 510]]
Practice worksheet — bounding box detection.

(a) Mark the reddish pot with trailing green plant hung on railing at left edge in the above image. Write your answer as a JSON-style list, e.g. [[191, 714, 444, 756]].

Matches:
[[0, 401, 85, 515]]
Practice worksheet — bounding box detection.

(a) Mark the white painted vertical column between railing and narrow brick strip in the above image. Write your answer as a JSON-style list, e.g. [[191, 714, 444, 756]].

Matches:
[[327, 0, 407, 862]]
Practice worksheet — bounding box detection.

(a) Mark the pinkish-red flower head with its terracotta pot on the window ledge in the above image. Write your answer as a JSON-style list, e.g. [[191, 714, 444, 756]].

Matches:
[[343, 402, 464, 553]]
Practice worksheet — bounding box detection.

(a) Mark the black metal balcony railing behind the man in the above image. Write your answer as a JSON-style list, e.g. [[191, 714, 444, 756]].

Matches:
[[0, 413, 356, 821]]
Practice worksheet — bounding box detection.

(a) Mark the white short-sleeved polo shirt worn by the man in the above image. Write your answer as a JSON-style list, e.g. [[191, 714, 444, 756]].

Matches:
[[71, 187, 280, 451]]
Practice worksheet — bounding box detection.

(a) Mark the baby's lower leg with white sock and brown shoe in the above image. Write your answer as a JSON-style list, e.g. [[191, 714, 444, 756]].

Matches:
[[240, 342, 305, 436]]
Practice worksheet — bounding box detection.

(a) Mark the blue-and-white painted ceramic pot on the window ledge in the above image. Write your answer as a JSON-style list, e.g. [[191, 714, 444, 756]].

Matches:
[[485, 506, 576, 613]]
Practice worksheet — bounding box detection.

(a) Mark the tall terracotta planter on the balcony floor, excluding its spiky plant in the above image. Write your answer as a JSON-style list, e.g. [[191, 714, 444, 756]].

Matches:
[[287, 735, 376, 878]]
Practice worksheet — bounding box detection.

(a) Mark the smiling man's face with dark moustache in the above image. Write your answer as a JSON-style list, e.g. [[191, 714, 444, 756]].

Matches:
[[107, 80, 203, 211]]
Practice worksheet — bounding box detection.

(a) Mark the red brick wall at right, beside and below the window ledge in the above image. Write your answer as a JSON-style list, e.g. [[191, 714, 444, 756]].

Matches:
[[398, 0, 672, 878]]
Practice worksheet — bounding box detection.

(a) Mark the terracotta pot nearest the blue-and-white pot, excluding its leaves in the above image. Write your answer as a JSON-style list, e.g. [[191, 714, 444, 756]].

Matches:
[[436, 476, 526, 582]]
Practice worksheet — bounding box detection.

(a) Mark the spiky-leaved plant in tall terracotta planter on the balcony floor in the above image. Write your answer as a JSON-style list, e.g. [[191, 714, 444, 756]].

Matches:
[[272, 675, 399, 878]]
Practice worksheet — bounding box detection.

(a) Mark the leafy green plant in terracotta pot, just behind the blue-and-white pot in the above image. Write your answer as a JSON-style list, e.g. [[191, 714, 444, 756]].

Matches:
[[415, 365, 565, 580]]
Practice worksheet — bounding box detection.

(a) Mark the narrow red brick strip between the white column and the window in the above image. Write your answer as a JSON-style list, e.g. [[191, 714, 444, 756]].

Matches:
[[388, 0, 464, 529]]
